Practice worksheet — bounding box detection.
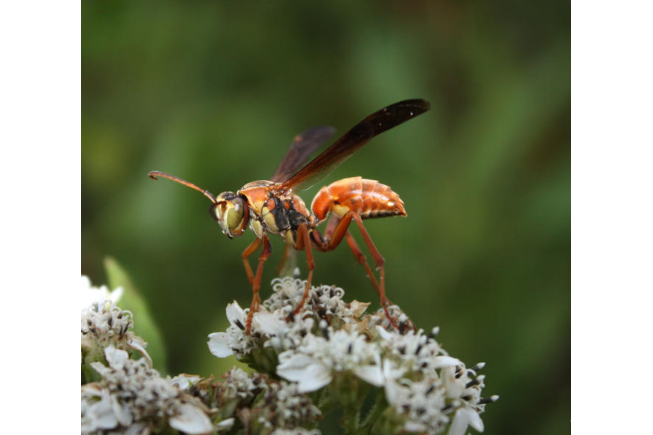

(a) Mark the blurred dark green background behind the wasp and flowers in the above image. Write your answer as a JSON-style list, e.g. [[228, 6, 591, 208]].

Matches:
[[81, 0, 571, 434]]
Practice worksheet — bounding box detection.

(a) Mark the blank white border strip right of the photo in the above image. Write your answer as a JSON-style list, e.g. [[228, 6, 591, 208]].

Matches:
[[572, 2, 653, 434]]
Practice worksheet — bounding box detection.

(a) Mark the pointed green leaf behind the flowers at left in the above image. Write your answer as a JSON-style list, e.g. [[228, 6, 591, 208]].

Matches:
[[104, 257, 167, 375]]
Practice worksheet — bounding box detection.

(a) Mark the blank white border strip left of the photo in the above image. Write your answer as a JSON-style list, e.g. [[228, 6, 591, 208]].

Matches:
[[0, 2, 81, 433]]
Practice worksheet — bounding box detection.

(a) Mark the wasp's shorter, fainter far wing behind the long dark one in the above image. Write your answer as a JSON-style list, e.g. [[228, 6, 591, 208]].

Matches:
[[270, 126, 336, 183]]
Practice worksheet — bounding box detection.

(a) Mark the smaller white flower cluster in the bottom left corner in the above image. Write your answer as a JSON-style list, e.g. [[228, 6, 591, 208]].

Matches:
[[82, 346, 214, 434]]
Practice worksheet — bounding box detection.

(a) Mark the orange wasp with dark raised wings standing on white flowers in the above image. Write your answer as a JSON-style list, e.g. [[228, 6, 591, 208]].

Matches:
[[148, 99, 430, 334]]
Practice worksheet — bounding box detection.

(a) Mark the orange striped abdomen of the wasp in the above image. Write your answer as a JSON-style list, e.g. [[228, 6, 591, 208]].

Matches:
[[311, 177, 406, 221]]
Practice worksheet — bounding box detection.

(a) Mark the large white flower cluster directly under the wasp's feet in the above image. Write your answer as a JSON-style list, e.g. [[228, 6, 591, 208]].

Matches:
[[209, 277, 498, 435]]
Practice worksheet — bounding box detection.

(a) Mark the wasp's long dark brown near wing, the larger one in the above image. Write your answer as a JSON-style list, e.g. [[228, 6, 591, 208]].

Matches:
[[281, 99, 431, 190]]
